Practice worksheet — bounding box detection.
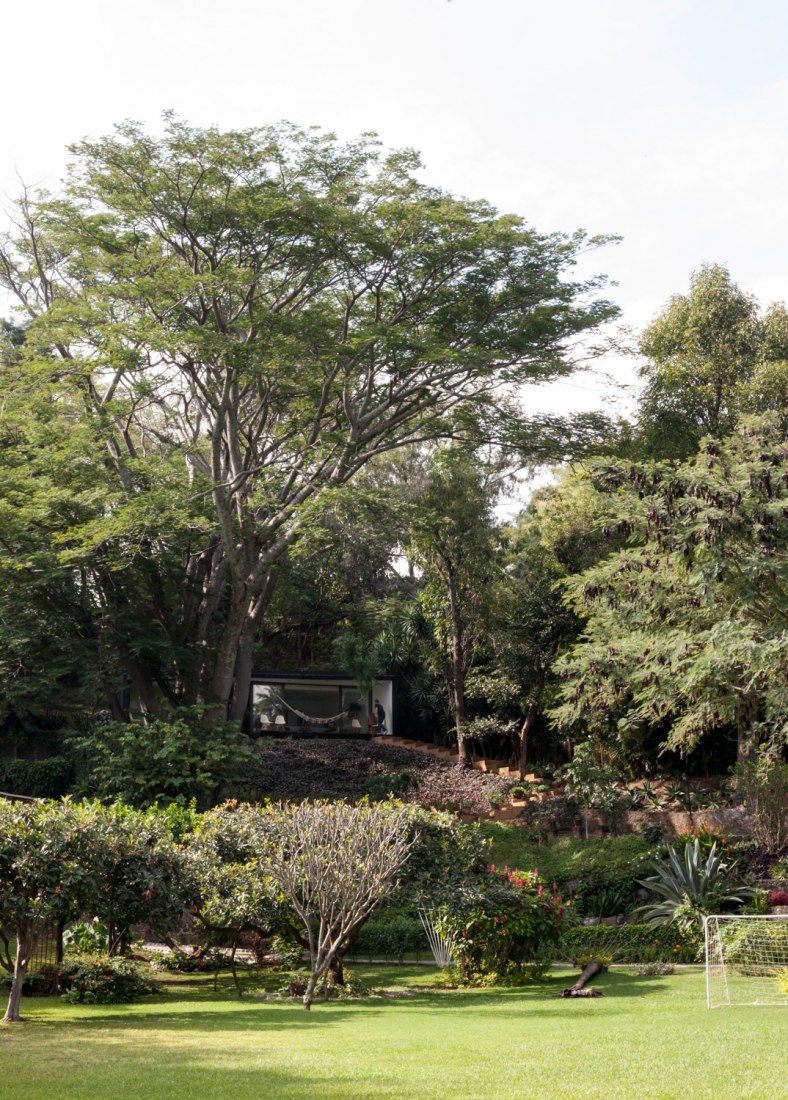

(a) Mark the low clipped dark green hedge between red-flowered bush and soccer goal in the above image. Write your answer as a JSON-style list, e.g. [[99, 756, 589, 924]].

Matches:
[[563, 924, 703, 963]]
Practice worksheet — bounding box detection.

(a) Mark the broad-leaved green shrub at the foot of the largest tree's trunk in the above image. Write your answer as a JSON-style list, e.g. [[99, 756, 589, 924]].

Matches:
[[72, 708, 251, 806]]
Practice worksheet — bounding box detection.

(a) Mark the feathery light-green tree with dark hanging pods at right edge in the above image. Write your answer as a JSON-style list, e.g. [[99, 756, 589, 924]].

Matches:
[[554, 418, 788, 756]]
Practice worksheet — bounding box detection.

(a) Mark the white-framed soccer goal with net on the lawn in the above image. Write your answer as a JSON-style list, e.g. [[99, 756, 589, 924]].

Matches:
[[703, 916, 788, 1009]]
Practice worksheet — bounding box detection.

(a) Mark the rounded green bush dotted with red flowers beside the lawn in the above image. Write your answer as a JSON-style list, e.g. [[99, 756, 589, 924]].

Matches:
[[438, 866, 566, 985]]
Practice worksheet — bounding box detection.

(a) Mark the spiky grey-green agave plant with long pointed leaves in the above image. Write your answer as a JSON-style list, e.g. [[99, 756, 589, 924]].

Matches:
[[637, 839, 753, 932]]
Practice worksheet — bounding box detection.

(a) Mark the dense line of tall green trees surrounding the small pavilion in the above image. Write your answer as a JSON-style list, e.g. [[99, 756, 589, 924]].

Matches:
[[0, 118, 788, 787]]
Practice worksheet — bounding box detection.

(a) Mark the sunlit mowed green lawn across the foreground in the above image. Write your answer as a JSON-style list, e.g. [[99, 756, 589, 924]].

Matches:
[[0, 967, 788, 1100]]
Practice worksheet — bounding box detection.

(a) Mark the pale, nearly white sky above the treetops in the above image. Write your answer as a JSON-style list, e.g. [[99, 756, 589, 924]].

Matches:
[[0, 0, 788, 420]]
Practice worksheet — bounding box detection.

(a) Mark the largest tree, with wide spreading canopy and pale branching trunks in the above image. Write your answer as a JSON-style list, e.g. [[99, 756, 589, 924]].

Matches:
[[0, 118, 614, 717]]
